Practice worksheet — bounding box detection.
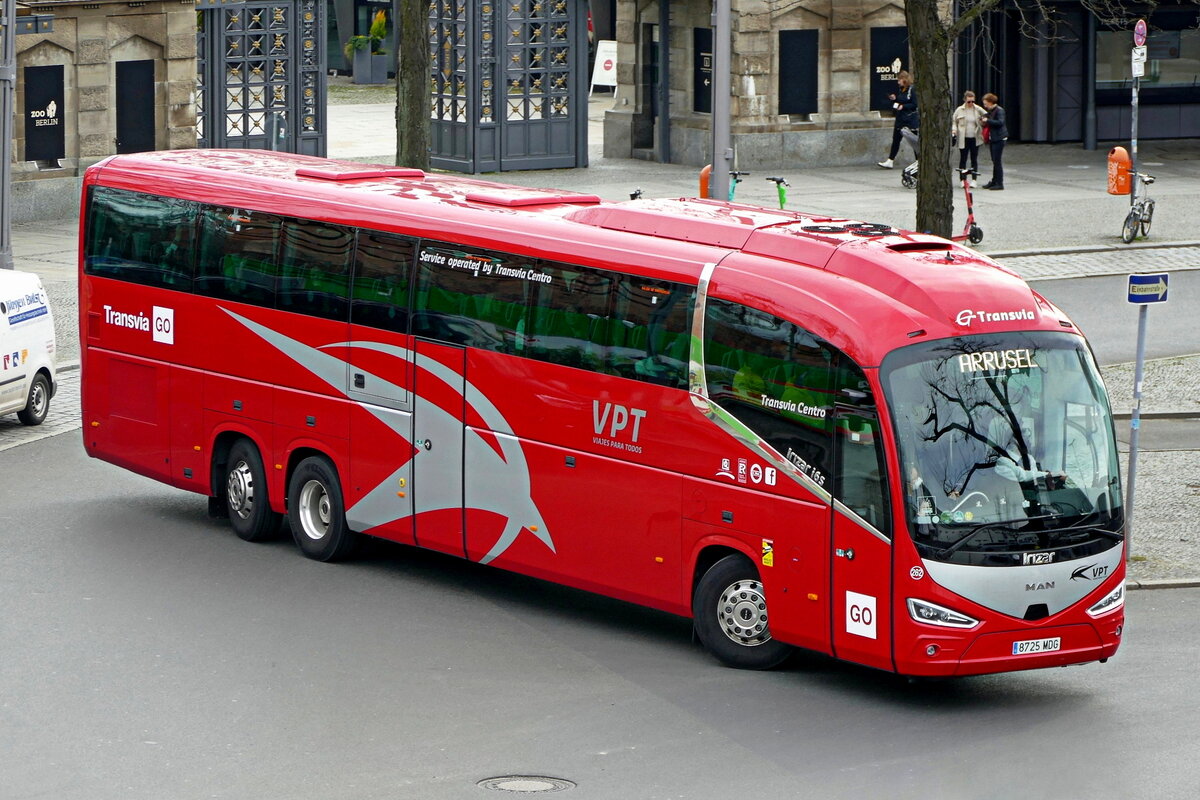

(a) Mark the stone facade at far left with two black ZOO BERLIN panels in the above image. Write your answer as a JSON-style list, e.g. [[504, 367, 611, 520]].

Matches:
[[13, 0, 196, 196]]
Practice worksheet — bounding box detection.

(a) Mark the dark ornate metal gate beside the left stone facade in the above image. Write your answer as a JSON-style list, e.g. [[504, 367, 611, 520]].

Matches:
[[196, 0, 328, 156]]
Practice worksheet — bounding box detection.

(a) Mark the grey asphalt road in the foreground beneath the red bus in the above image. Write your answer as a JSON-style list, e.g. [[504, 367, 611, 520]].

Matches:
[[0, 434, 1200, 800]]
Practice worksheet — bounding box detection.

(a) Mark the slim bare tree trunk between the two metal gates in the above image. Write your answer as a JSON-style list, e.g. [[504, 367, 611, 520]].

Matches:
[[396, 0, 430, 169]]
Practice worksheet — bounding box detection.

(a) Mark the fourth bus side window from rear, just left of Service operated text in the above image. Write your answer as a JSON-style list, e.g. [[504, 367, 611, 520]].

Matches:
[[350, 230, 413, 333]]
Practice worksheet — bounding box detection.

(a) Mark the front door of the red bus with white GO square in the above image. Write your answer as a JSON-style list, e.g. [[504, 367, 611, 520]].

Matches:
[[832, 379, 894, 670]]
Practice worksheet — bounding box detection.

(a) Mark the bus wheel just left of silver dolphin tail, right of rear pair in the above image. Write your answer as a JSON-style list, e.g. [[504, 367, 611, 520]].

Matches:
[[288, 456, 360, 561]]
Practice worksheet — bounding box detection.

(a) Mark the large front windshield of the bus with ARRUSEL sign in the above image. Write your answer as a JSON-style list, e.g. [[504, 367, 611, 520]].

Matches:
[[883, 332, 1123, 566]]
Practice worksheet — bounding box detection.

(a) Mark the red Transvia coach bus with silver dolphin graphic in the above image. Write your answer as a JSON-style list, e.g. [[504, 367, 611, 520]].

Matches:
[[79, 150, 1124, 675]]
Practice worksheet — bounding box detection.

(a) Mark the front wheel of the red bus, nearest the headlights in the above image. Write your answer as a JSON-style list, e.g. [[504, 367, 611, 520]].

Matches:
[[691, 555, 792, 669]]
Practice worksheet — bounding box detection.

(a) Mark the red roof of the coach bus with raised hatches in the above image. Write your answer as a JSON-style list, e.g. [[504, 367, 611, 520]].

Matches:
[[85, 150, 1075, 366]]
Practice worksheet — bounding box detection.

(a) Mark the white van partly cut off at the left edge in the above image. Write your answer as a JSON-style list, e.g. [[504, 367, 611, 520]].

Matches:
[[0, 270, 58, 425]]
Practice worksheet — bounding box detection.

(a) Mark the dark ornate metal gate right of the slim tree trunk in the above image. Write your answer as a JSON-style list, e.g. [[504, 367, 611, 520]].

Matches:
[[430, 0, 588, 173]]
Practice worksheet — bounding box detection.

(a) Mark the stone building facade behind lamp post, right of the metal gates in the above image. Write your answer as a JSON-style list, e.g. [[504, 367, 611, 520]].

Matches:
[[605, 0, 908, 169]]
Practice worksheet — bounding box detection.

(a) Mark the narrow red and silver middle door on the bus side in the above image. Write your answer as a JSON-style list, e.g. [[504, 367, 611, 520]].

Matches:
[[413, 339, 467, 557]]
